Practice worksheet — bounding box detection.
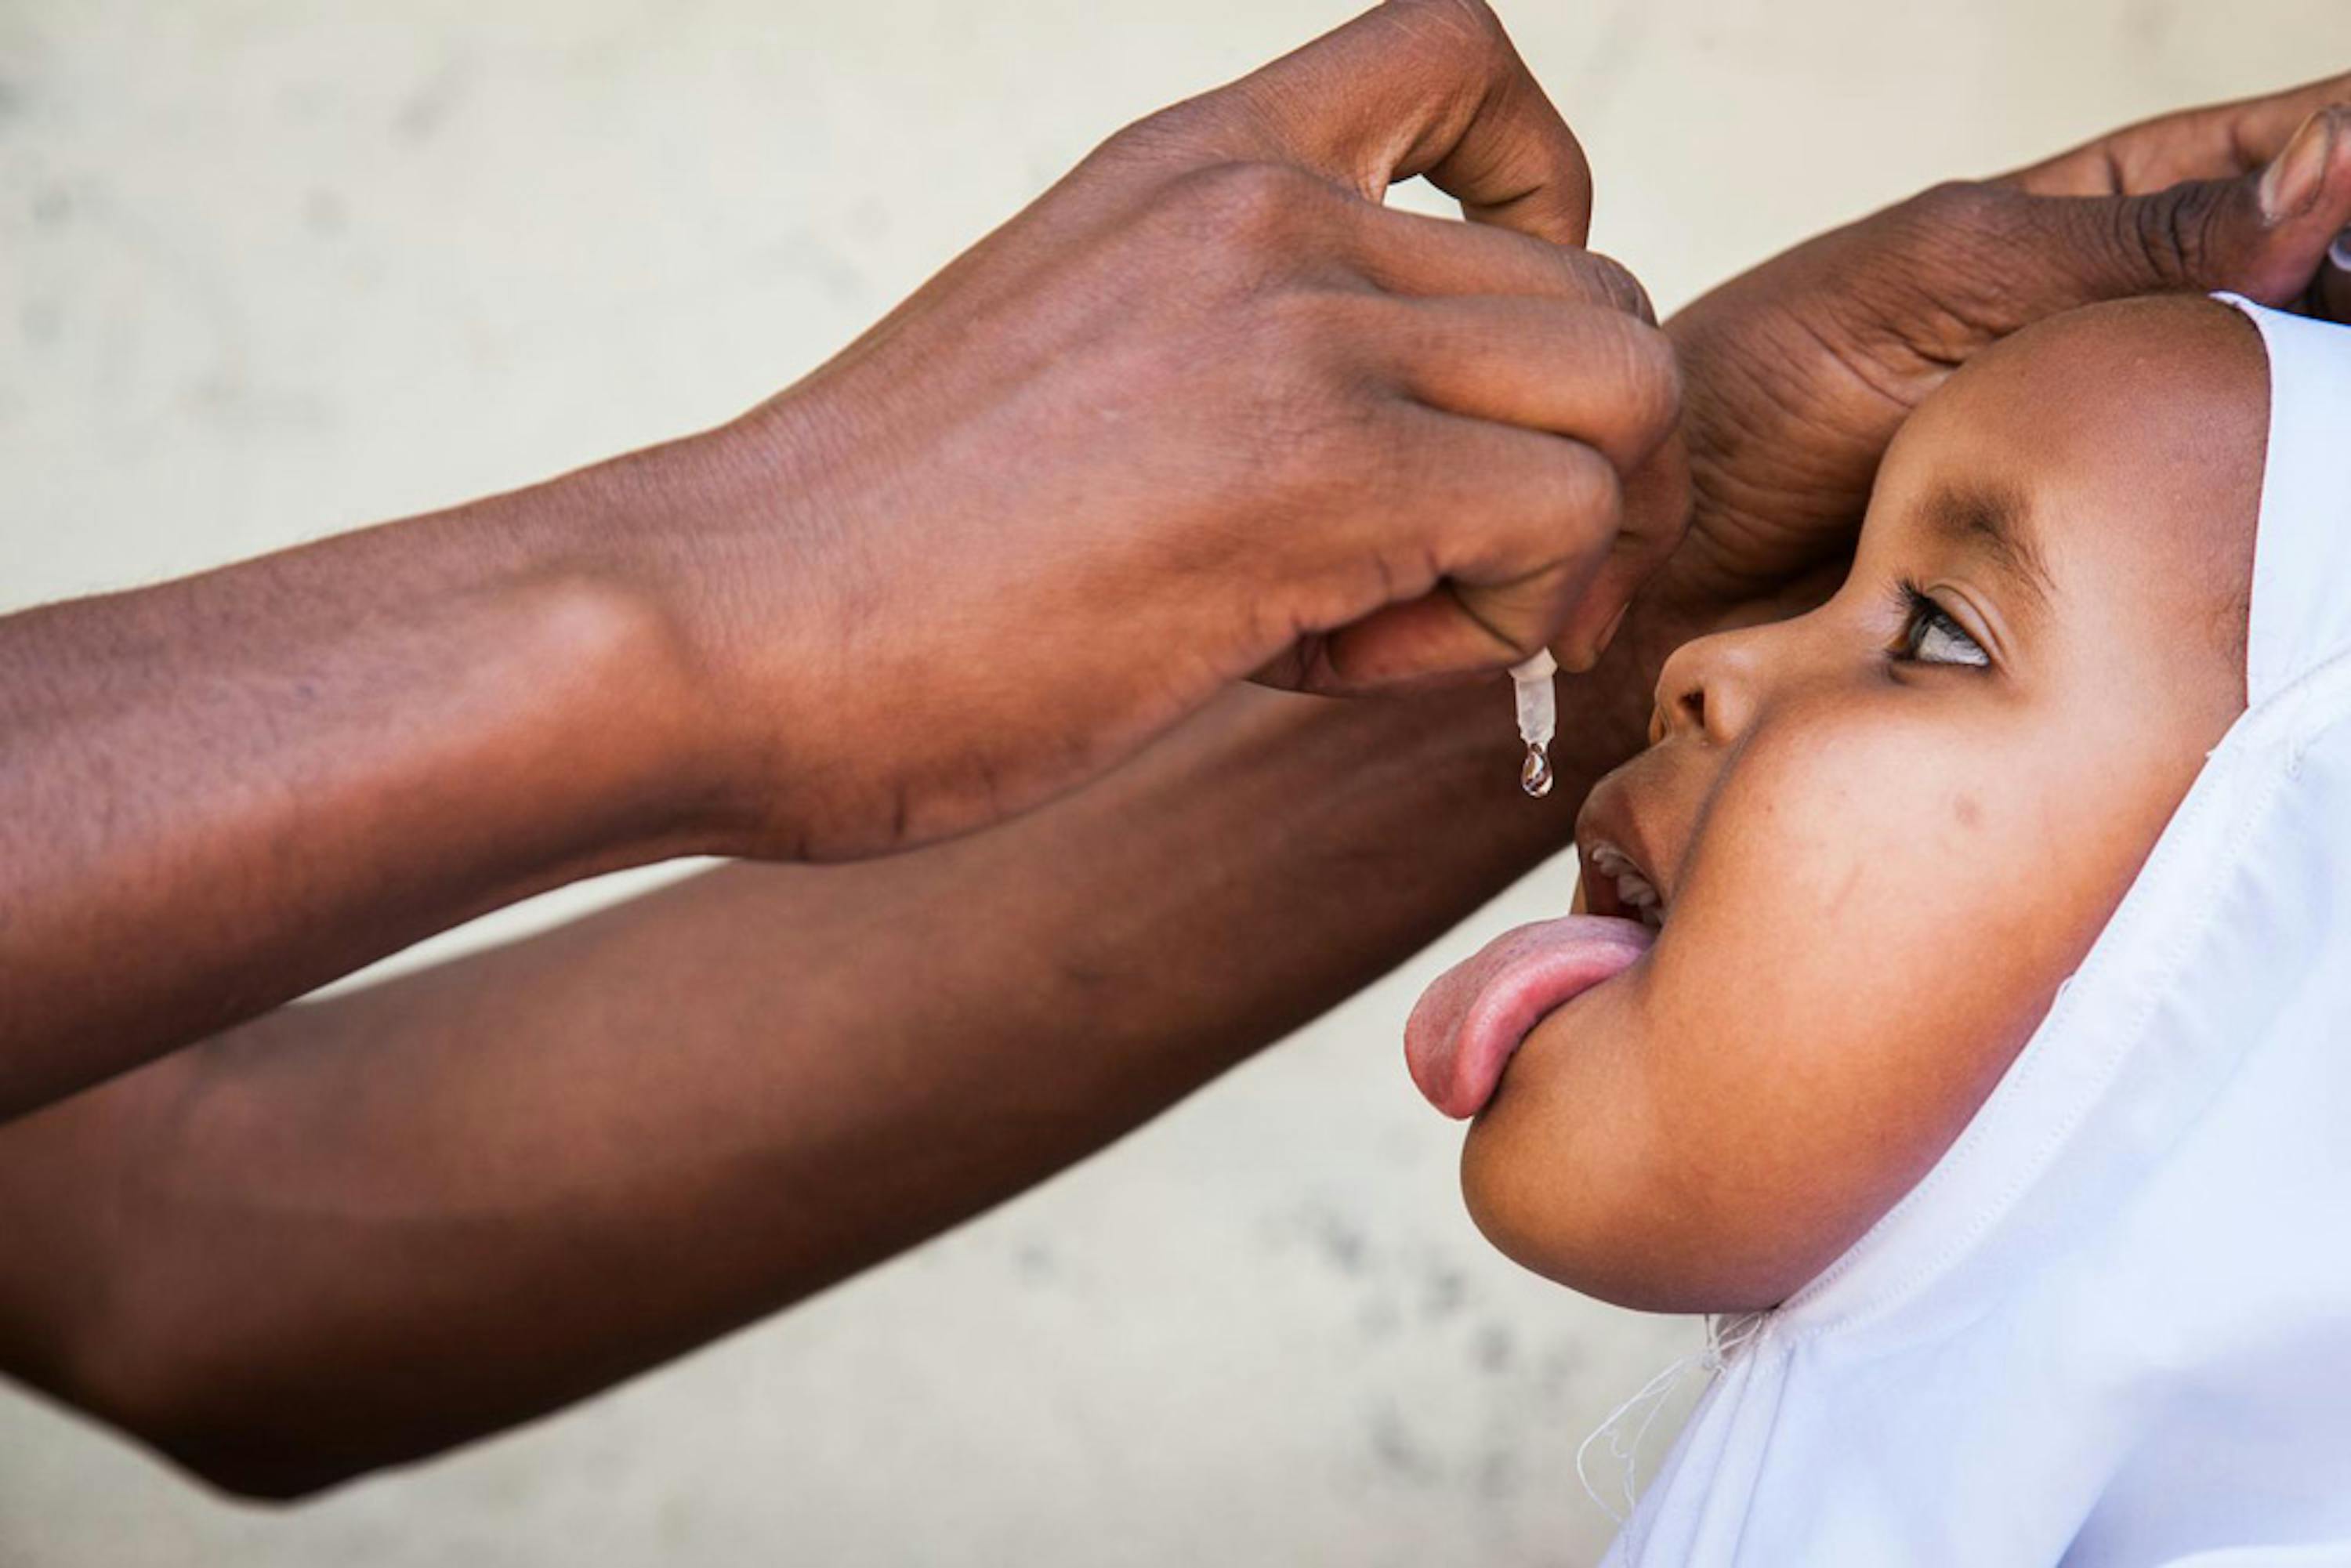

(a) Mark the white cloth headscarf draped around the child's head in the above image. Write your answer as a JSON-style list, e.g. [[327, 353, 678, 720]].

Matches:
[[1608, 299, 2351, 1568]]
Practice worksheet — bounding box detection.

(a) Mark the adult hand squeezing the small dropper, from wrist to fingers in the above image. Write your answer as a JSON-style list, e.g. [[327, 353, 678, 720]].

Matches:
[[672, 0, 1686, 858]]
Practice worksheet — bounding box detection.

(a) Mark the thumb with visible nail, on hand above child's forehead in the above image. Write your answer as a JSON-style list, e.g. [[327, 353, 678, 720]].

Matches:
[[2034, 106, 2351, 306]]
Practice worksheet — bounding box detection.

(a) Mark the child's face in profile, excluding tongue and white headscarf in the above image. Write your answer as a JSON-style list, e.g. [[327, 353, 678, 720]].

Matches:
[[1462, 299, 2269, 1309]]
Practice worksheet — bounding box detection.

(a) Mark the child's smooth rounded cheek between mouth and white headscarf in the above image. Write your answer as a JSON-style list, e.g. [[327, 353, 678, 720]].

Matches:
[[1617, 705, 2062, 1288]]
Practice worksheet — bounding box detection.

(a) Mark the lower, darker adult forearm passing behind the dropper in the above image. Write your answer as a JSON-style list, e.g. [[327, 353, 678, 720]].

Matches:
[[0, 611, 1674, 1490]]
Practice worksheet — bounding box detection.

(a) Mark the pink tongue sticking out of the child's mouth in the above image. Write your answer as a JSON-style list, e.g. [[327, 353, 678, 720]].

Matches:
[[1404, 914, 1655, 1117]]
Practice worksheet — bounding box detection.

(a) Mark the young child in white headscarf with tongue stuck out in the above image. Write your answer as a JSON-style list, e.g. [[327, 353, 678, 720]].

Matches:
[[1408, 299, 2351, 1568]]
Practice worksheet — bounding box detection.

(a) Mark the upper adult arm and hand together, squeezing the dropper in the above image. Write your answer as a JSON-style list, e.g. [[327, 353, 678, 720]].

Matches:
[[0, 0, 1681, 1117]]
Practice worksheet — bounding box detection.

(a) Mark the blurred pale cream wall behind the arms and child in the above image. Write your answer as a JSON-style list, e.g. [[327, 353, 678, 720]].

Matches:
[[0, 0, 2351, 1568]]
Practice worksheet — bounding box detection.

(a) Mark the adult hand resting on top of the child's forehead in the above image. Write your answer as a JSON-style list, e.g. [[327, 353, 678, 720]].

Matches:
[[1660, 75, 2351, 621]]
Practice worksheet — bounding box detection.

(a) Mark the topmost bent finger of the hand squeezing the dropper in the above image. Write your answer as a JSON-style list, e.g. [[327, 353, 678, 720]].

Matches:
[[1192, 0, 1592, 244]]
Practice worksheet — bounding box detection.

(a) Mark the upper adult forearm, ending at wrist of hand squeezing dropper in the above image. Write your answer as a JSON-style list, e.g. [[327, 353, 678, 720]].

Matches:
[[0, 444, 743, 1119]]
